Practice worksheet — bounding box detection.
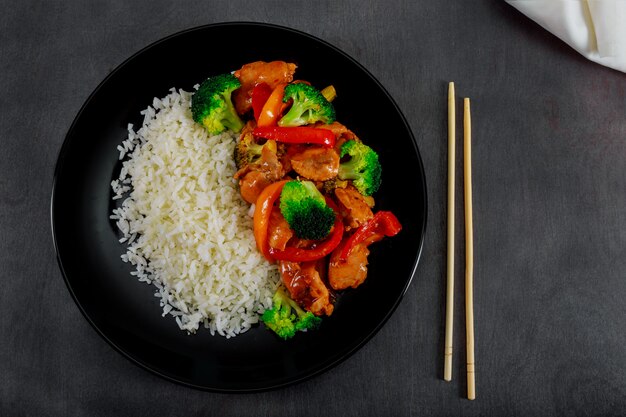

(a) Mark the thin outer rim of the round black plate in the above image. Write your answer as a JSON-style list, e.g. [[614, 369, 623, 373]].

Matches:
[[50, 21, 428, 393]]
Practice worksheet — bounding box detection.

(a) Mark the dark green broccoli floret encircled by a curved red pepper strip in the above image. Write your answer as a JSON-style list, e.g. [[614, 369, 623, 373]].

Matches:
[[280, 180, 335, 240]]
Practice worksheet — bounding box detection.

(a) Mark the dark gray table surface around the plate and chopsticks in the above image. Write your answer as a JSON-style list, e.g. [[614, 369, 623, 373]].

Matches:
[[0, 0, 626, 417]]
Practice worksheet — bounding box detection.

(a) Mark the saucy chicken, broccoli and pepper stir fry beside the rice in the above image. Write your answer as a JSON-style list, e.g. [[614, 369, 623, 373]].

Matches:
[[191, 61, 402, 339]]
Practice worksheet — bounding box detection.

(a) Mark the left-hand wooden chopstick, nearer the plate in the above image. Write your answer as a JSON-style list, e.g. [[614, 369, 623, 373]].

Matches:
[[443, 82, 456, 381]]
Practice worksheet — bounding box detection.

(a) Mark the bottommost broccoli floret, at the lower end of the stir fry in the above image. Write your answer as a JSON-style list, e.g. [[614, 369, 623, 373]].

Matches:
[[261, 287, 322, 339]]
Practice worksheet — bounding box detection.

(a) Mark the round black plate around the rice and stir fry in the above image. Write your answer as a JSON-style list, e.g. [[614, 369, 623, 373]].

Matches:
[[52, 23, 426, 392]]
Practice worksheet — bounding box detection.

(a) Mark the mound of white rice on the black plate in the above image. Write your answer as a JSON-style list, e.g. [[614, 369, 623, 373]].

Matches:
[[111, 89, 279, 337]]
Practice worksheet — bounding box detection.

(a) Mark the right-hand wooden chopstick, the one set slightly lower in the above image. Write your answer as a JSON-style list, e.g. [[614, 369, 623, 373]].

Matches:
[[463, 98, 476, 400]]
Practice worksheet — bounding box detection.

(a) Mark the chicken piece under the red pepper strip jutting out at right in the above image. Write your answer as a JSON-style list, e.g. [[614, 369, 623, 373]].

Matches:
[[328, 241, 370, 290]]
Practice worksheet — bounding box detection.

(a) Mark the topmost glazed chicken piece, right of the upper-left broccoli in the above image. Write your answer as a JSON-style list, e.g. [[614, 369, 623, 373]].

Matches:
[[233, 61, 296, 114]]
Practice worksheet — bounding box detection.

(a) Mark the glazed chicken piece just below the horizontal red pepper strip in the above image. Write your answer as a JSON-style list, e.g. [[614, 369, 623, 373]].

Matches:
[[291, 147, 339, 181]]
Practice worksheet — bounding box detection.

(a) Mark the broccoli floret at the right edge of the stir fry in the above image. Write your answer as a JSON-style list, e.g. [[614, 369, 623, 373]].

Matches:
[[337, 140, 382, 196]]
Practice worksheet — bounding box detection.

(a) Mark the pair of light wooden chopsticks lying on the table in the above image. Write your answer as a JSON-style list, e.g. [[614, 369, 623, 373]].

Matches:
[[443, 82, 476, 400]]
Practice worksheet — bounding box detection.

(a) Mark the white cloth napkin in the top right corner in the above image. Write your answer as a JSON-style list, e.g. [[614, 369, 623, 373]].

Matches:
[[506, 0, 626, 72]]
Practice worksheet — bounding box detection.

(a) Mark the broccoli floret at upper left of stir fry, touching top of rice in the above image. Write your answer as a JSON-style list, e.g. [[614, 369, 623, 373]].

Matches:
[[191, 74, 243, 135]]
